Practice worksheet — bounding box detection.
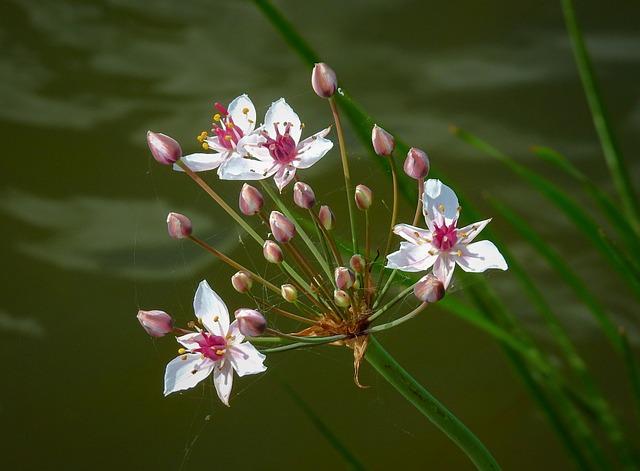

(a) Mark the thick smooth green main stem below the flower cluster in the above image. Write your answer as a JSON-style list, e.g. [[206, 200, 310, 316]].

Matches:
[[365, 336, 500, 470]]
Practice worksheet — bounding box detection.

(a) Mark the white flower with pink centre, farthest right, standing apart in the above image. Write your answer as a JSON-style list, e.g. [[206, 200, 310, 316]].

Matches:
[[387, 179, 507, 288]]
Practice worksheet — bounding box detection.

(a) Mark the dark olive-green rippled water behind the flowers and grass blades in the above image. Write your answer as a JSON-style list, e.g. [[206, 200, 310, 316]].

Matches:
[[0, 0, 640, 470]]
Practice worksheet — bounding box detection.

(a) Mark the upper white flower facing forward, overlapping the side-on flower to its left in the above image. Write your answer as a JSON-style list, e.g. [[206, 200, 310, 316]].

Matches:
[[220, 98, 333, 191]]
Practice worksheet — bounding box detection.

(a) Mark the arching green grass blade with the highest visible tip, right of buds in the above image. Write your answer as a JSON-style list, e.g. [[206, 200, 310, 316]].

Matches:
[[452, 128, 640, 299]]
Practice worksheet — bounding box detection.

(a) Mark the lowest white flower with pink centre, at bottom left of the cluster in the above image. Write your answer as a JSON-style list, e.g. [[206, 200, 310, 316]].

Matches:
[[164, 280, 267, 406]]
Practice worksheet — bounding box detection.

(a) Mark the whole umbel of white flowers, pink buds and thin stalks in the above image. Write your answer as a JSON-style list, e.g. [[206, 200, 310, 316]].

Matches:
[[138, 63, 507, 405]]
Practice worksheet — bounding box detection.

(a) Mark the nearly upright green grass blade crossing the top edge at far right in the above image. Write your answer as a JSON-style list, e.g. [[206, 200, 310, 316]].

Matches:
[[562, 0, 640, 228]]
